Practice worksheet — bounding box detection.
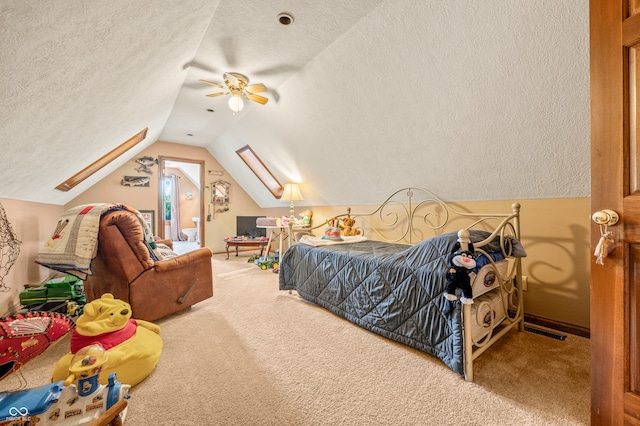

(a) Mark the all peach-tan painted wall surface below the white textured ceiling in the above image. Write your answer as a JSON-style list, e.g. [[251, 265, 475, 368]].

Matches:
[[0, 165, 594, 328]]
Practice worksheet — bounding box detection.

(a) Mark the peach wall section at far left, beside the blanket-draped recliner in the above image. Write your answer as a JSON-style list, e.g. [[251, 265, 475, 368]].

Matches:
[[0, 198, 64, 316]]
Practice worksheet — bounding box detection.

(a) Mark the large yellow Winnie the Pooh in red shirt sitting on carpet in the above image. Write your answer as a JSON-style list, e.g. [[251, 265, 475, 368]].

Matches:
[[52, 293, 162, 386]]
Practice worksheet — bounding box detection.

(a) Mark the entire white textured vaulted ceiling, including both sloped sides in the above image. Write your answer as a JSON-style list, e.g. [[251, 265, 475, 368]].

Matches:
[[0, 0, 590, 207]]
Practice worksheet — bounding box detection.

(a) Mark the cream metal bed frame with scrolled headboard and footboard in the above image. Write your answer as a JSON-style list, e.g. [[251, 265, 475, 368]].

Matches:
[[298, 187, 524, 381]]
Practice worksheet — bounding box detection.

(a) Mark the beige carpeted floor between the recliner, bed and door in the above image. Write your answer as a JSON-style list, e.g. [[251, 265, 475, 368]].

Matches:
[[2, 254, 590, 426]]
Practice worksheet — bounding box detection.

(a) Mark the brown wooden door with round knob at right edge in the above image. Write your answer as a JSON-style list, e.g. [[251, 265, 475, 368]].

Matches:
[[590, 0, 640, 425]]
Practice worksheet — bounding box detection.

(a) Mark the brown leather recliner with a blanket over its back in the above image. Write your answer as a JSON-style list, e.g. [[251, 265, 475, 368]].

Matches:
[[84, 210, 213, 321]]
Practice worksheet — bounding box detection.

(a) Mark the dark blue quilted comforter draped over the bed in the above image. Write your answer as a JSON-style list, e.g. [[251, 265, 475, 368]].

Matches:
[[279, 233, 468, 375]]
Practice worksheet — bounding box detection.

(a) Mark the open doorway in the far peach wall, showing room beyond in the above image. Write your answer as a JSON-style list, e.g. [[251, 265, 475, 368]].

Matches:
[[158, 156, 205, 254]]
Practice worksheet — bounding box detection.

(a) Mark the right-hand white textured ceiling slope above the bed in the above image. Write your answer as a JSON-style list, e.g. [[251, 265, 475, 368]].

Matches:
[[208, 0, 590, 205]]
